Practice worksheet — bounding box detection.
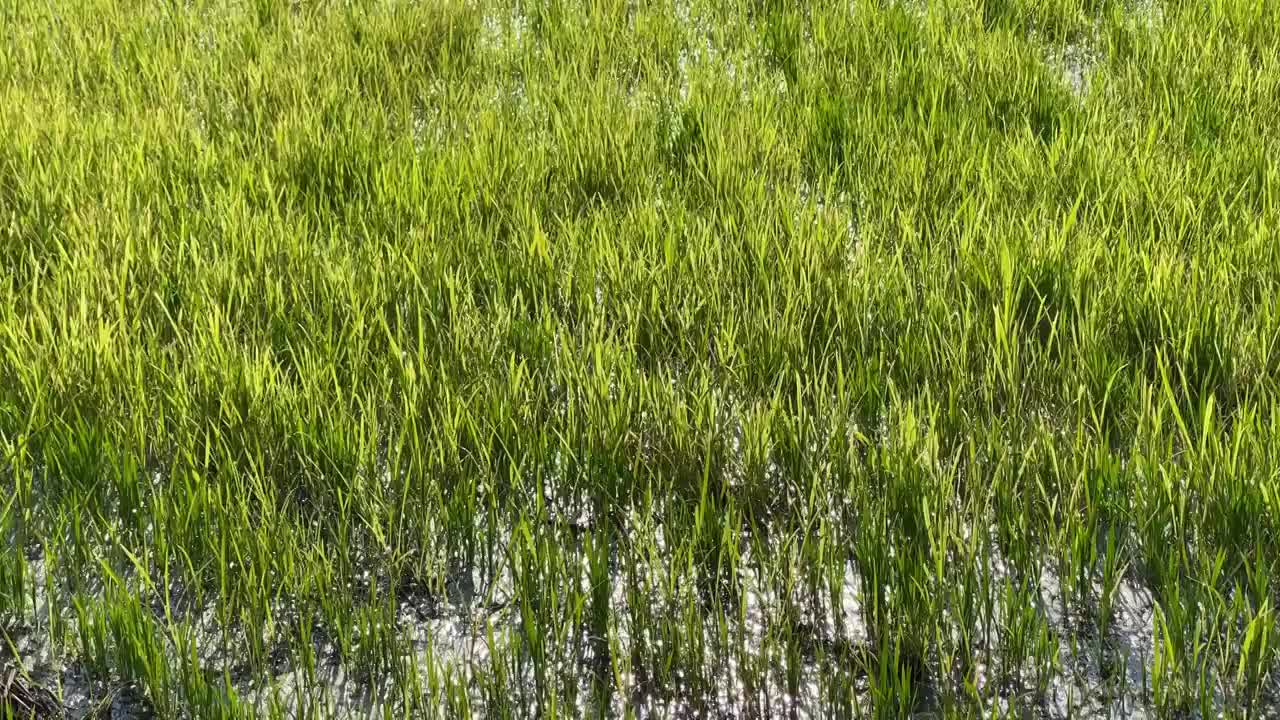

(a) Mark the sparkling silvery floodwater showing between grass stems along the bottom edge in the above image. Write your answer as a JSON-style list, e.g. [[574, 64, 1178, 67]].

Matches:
[[8, 507, 1280, 720]]
